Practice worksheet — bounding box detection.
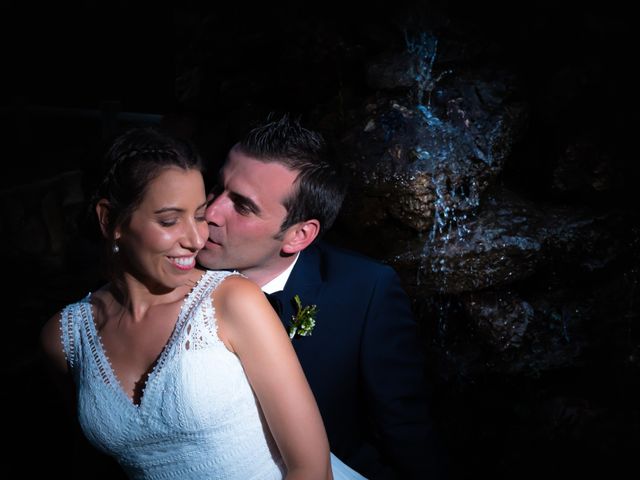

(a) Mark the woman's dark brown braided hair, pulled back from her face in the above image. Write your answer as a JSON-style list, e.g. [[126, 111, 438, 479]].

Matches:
[[90, 127, 204, 292]]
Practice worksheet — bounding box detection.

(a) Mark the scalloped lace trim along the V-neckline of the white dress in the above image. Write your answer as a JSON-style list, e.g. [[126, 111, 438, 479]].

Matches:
[[85, 272, 208, 410]]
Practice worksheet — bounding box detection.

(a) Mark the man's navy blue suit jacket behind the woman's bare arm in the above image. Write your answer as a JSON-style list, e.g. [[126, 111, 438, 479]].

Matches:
[[275, 242, 440, 479]]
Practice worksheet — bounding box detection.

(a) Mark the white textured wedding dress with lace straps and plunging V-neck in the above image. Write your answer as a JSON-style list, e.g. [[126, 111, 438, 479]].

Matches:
[[61, 271, 285, 480]]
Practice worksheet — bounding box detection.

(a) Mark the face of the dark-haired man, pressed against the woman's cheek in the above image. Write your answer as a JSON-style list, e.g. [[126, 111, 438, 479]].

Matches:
[[198, 149, 297, 285]]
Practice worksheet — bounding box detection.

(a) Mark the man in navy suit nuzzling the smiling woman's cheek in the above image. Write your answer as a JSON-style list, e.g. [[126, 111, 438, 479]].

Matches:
[[198, 116, 442, 479]]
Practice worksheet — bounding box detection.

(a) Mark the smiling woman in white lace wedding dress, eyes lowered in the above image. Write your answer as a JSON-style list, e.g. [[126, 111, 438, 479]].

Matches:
[[41, 128, 364, 480]]
